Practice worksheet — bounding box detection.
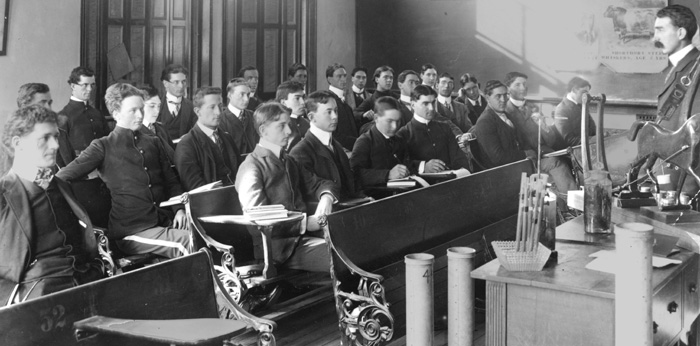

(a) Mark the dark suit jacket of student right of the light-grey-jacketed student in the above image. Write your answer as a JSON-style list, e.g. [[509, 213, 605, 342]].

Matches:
[[289, 132, 362, 204]]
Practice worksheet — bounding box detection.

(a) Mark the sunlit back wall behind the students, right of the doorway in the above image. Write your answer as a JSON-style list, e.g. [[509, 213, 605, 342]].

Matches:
[[356, 0, 700, 128]]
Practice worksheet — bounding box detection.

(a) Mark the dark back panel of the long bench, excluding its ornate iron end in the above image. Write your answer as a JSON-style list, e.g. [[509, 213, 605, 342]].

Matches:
[[328, 160, 533, 272]]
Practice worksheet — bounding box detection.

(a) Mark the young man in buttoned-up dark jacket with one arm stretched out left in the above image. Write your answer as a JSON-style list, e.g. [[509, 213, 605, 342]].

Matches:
[[56, 83, 190, 258]]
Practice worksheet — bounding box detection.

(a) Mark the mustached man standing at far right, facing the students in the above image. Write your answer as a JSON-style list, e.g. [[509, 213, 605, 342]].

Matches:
[[653, 5, 700, 193]]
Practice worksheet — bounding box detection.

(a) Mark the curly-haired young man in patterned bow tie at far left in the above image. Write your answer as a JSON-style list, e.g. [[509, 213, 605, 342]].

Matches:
[[0, 105, 104, 307]]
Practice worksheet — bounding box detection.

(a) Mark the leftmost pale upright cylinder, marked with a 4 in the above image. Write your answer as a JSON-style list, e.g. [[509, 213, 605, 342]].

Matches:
[[404, 253, 435, 346]]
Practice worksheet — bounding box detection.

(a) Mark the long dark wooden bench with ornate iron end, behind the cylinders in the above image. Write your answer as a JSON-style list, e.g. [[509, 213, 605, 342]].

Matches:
[[324, 160, 533, 345]]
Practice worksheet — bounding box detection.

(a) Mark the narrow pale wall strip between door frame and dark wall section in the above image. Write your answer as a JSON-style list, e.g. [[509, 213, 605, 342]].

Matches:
[[316, 0, 356, 90]]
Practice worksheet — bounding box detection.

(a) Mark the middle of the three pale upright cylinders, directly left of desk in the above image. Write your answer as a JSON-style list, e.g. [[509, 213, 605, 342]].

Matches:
[[447, 247, 476, 346]]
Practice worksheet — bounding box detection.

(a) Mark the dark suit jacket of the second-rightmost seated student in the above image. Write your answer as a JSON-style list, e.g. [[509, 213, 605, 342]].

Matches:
[[506, 100, 559, 157]]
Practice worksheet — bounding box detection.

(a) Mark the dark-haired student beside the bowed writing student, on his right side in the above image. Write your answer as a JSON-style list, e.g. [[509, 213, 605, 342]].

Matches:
[[396, 85, 469, 174]]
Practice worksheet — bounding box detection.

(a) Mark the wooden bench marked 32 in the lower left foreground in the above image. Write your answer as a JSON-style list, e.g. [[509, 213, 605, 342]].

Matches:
[[0, 251, 275, 345]]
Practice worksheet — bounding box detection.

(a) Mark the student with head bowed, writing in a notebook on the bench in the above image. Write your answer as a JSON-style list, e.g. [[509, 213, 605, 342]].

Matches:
[[350, 96, 410, 188]]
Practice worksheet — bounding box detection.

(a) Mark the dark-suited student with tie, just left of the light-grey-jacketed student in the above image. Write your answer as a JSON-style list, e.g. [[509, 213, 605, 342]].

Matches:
[[175, 86, 241, 190]]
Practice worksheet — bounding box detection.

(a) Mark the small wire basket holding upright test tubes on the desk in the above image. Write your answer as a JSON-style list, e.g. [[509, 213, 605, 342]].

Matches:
[[491, 241, 552, 272]]
